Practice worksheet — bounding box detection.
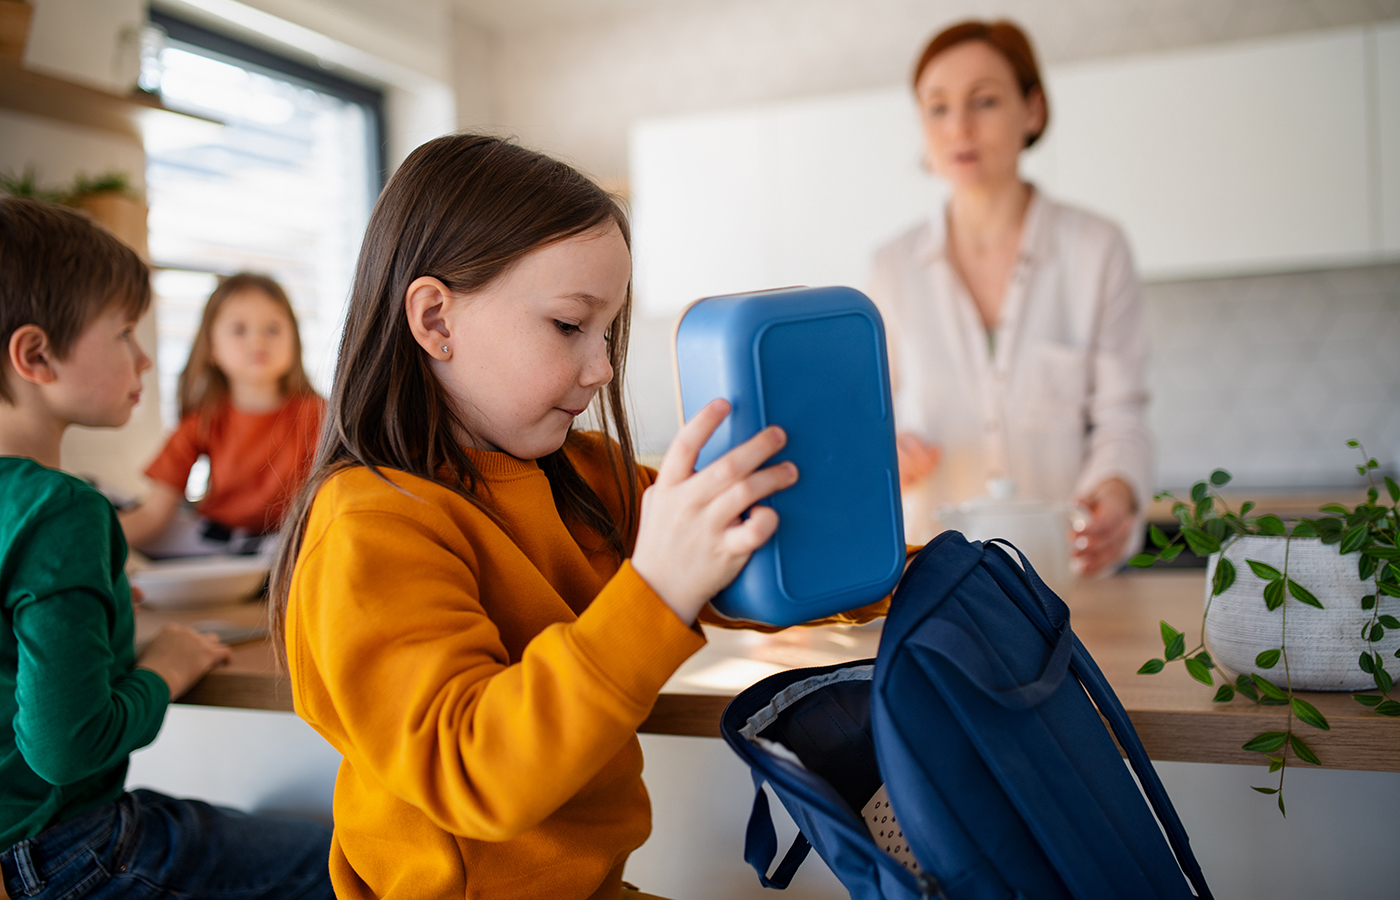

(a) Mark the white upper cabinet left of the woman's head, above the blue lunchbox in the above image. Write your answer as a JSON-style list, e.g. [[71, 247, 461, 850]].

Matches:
[[631, 88, 942, 315]]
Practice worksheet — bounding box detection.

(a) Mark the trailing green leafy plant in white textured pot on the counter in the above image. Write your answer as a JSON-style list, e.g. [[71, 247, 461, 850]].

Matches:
[[1128, 441, 1400, 815]]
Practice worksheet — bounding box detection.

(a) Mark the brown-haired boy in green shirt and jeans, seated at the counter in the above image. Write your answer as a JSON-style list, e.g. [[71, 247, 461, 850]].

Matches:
[[0, 197, 333, 900]]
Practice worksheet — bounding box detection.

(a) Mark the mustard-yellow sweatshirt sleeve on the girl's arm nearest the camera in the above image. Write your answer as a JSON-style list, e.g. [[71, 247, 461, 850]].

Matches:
[[287, 511, 704, 841]]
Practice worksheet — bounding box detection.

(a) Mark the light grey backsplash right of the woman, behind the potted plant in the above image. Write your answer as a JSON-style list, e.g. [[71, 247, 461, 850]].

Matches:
[[1144, 265, 1400, 488]]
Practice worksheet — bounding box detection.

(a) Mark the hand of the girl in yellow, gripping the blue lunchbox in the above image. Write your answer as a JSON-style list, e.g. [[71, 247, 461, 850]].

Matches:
[[631, 400, 797, 624]]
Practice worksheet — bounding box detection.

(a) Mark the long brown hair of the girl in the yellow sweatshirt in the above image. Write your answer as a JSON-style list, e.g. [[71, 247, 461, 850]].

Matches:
[[269, 134, 640, 663]]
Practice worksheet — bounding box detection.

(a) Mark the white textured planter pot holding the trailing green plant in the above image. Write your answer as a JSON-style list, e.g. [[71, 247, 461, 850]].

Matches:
[[1205, 535, 1400, 690]]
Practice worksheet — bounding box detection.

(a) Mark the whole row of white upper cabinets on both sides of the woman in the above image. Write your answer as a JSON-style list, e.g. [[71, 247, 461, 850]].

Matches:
[[631, 25, 1400, 314]]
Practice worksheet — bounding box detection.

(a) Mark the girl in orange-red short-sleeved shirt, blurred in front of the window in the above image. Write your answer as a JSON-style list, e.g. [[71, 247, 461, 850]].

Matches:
[[120, 273, 325, 557]]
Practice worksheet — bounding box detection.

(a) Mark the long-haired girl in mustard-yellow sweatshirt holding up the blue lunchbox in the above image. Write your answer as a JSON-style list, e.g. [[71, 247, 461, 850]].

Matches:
[[273, 134, 851, 900]]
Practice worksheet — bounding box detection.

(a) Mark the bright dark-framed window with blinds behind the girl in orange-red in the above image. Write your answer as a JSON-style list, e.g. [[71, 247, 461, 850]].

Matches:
[[143, 10, 384, 427]]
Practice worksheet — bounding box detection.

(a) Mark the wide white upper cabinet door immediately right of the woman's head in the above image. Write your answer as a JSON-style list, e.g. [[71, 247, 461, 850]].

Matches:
[[1028, 29, 1378, 277]]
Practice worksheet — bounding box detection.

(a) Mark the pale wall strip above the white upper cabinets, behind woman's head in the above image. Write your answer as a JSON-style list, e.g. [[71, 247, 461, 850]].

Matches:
[[467, 0, 1400, 179]]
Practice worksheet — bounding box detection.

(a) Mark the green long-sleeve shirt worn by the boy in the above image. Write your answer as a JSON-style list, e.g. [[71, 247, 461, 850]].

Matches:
[[0, 456, 169, 852]]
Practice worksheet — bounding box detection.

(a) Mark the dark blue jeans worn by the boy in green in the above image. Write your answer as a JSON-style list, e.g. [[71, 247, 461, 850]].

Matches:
[[0, 791, 335, 900]]
